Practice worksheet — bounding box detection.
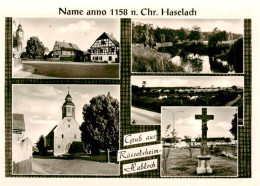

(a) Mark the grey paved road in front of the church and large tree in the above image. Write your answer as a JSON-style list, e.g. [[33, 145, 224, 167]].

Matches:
[[32, 158, 120, 175]]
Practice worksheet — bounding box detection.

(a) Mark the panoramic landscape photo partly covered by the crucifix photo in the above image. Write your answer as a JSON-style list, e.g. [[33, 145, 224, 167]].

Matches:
[[131, 76, 244, 125]]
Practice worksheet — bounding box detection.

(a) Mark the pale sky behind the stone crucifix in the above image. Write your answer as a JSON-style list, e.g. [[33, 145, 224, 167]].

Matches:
[[161, 106, 237, 139]]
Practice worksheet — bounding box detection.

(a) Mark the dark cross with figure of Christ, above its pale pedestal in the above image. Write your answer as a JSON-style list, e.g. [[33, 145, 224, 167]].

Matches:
[[195, 108, 214, 156]]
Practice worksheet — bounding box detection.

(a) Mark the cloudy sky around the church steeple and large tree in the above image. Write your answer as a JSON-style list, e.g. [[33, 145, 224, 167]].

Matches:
[[13, 84, 120, 143]]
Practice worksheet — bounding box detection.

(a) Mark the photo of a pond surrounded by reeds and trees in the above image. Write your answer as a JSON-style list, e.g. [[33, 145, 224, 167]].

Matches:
[[132, 19, 244, 73]]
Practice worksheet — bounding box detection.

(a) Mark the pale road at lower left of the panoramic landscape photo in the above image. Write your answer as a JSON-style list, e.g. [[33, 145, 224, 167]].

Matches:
[[131, 106, 161, 125]]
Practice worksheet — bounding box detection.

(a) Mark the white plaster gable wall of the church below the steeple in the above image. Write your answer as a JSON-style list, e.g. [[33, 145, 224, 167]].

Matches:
[[54, 117, 81, 156]]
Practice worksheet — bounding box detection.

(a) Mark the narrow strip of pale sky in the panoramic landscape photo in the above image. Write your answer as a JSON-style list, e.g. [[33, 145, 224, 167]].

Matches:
[[131, 76, 244, 87]]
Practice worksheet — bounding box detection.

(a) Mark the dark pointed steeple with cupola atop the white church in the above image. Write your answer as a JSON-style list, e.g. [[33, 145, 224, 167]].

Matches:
[[62, 87, 75, 119]]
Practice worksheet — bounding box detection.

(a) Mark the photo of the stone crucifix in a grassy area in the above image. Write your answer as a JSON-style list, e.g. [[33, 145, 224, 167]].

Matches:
[[161, 106, 238, 177]]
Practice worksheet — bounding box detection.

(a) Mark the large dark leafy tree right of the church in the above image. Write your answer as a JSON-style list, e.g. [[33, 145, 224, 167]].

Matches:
[[80, 93, 119, 162]]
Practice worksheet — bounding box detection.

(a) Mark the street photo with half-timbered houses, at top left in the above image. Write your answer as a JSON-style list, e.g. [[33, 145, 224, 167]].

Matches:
[[12, 18, 120, 79]]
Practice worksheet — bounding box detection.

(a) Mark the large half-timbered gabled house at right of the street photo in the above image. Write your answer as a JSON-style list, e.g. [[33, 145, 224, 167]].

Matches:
[[90, 32, 119, 63]]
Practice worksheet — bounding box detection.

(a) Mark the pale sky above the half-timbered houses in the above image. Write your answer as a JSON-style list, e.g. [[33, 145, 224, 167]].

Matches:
[[13, 18, 120, 51]]
